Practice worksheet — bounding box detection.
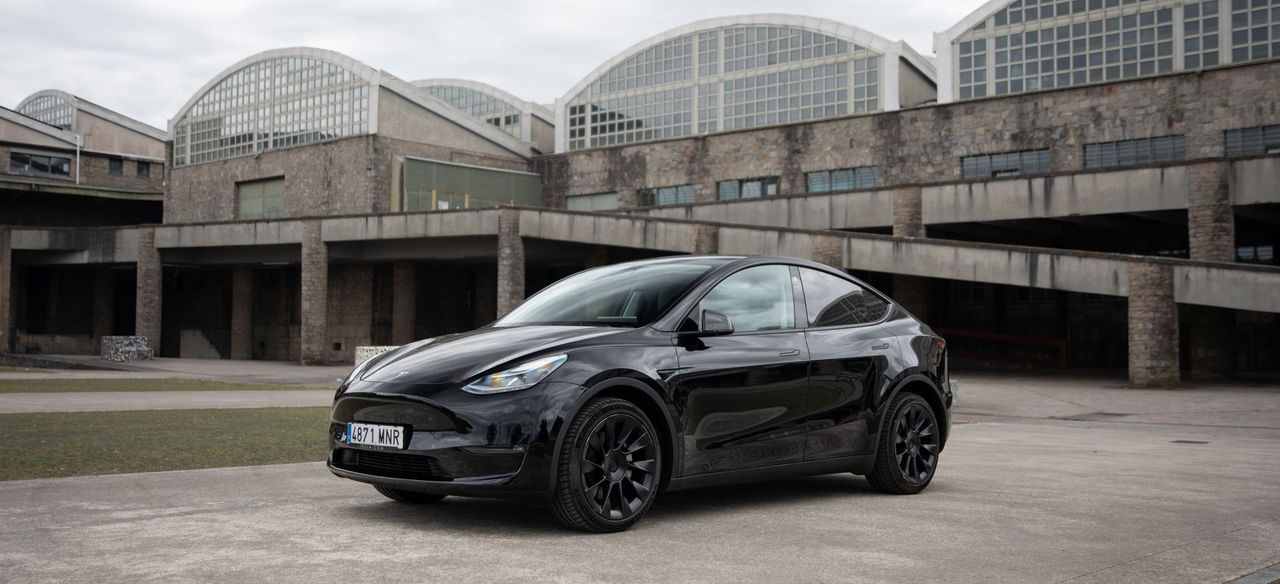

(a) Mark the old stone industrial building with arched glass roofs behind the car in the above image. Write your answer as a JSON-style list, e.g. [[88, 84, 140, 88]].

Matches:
[[0, 8, 1280, 385]]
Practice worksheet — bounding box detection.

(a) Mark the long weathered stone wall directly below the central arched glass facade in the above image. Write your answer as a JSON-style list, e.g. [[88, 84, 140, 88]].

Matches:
[[535, 63, 1280, 206]]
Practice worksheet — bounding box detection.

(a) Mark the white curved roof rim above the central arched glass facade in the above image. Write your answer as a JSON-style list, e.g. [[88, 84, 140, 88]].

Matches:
[[562, 14, 934, 101]]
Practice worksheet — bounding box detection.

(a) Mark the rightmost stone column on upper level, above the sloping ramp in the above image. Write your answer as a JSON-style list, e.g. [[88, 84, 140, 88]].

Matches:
[[1187, 161, 1235, 261]]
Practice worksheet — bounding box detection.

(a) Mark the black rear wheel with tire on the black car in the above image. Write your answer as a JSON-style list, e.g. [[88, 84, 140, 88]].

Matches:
[[867, 392, 942, 494]]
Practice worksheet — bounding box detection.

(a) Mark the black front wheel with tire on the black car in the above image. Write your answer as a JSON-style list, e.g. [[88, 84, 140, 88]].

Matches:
[[552, 397, 663, 533]]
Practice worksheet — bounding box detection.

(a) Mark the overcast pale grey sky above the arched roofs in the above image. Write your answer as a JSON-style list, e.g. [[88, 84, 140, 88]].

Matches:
[[0, 0, 983, 128]]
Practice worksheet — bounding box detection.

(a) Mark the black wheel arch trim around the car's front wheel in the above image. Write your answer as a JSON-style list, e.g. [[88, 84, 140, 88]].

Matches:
[[550, 377, 680, 491]]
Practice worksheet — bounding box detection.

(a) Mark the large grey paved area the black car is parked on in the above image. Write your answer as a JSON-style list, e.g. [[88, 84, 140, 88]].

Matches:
[[0, 374, 1280, 583]]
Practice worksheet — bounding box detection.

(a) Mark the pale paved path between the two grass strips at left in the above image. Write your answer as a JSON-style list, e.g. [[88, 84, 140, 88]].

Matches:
[[0, 389, 333, 414]]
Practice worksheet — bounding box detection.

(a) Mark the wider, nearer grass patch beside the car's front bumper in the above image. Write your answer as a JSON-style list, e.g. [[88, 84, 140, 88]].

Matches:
[[0, 407, 329, 480]]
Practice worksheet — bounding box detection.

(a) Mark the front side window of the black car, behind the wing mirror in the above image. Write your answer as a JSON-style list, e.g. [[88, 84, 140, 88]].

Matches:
[[698, 265, 796, 333]]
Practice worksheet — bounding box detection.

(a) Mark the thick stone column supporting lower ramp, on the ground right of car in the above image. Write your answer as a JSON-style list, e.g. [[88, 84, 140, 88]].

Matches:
[[1129, 263, 1181, 387]]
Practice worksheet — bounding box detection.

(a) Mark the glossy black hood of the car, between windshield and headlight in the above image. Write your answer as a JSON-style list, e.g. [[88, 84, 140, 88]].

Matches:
[[360, 327, 628, 384]]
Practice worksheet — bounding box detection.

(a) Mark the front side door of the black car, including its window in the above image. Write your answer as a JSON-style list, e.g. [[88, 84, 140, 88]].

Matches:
[[672, 265, 809, 476]]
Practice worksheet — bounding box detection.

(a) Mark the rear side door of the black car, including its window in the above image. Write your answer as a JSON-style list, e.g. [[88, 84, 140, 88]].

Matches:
[[799, 268, 897, 460]]
